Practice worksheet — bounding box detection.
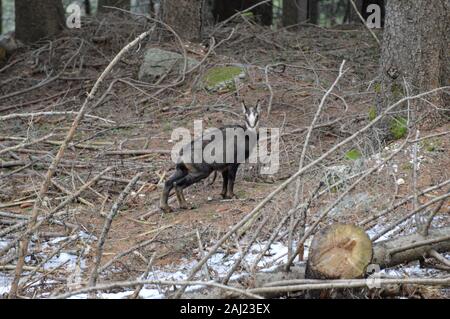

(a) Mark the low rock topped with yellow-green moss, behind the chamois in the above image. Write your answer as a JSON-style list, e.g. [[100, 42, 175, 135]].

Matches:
[[203, 66, 245, 90]]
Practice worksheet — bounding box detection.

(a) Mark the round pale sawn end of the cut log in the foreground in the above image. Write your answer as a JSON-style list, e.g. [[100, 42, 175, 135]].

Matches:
[[306, 224, 372, 279]]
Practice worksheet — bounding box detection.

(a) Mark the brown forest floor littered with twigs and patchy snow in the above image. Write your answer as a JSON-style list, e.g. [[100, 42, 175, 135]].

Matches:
[[0, 10, 450, 297]]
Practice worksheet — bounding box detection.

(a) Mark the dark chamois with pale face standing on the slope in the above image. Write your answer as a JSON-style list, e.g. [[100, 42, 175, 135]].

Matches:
[[160, 100, 261, 213]]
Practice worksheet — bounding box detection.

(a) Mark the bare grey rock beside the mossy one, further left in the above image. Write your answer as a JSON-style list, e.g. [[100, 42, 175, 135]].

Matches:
[[138, 48, 199, 82]]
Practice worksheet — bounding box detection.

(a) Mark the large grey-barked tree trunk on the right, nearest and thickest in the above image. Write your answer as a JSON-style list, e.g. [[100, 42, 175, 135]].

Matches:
[[375, 0, 449, 138]]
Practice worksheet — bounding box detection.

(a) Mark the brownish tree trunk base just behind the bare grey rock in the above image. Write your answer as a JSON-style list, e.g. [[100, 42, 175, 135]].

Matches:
[[163, 0, 203, 41]]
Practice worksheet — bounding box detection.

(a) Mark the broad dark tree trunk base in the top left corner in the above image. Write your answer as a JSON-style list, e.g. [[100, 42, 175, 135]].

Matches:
[[15, 0, 65, 43]]
